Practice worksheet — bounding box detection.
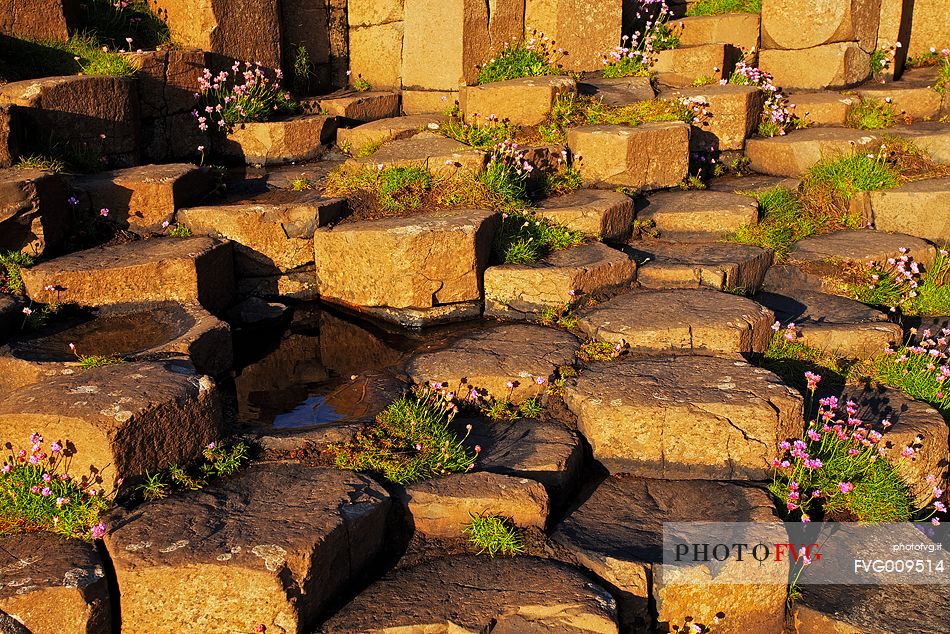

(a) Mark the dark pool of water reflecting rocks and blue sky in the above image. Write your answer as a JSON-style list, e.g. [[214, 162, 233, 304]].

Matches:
[[234, 304, 480, 429]]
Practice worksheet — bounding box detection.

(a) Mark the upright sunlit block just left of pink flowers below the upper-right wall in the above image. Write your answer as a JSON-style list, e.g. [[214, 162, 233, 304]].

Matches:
[[660, 82, 765, 152]]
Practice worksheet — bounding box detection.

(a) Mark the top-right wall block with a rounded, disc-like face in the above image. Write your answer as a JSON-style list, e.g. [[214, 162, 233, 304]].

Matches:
[[762, 0, 880, 50]]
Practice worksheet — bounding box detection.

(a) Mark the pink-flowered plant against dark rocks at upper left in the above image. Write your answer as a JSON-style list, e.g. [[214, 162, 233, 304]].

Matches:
[[192, 62, 298, 132]]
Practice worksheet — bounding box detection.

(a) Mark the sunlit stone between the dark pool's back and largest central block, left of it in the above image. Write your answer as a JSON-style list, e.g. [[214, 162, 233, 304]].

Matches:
[[175, 191, 348, 278]]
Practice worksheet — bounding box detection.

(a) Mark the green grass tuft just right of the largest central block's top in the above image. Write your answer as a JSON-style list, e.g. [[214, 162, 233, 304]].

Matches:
[[494, 211, 586, 264]]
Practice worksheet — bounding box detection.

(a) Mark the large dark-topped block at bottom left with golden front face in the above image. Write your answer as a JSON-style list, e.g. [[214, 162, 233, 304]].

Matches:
[[105, 463, 390, 633]]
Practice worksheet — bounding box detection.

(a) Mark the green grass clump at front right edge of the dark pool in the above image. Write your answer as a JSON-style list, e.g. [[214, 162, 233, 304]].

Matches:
[[327, 386, 477, 484]]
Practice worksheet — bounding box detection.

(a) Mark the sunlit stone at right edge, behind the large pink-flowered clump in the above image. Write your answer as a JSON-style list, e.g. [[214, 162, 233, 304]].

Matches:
[[841, 380, 950, 507]]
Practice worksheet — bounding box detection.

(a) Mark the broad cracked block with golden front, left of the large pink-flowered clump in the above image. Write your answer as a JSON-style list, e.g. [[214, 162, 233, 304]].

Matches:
[[564, 355, 803, 480]]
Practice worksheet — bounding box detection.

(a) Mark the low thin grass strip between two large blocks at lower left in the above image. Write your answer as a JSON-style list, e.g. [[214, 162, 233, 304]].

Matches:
[[136, 442, 248, 502]]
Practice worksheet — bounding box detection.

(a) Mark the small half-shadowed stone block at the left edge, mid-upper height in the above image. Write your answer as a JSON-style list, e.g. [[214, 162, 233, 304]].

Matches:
[[0, 168, 72, 255]]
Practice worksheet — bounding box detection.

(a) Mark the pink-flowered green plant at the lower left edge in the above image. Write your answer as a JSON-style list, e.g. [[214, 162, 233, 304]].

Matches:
[[0, 432, 113, 539]]
